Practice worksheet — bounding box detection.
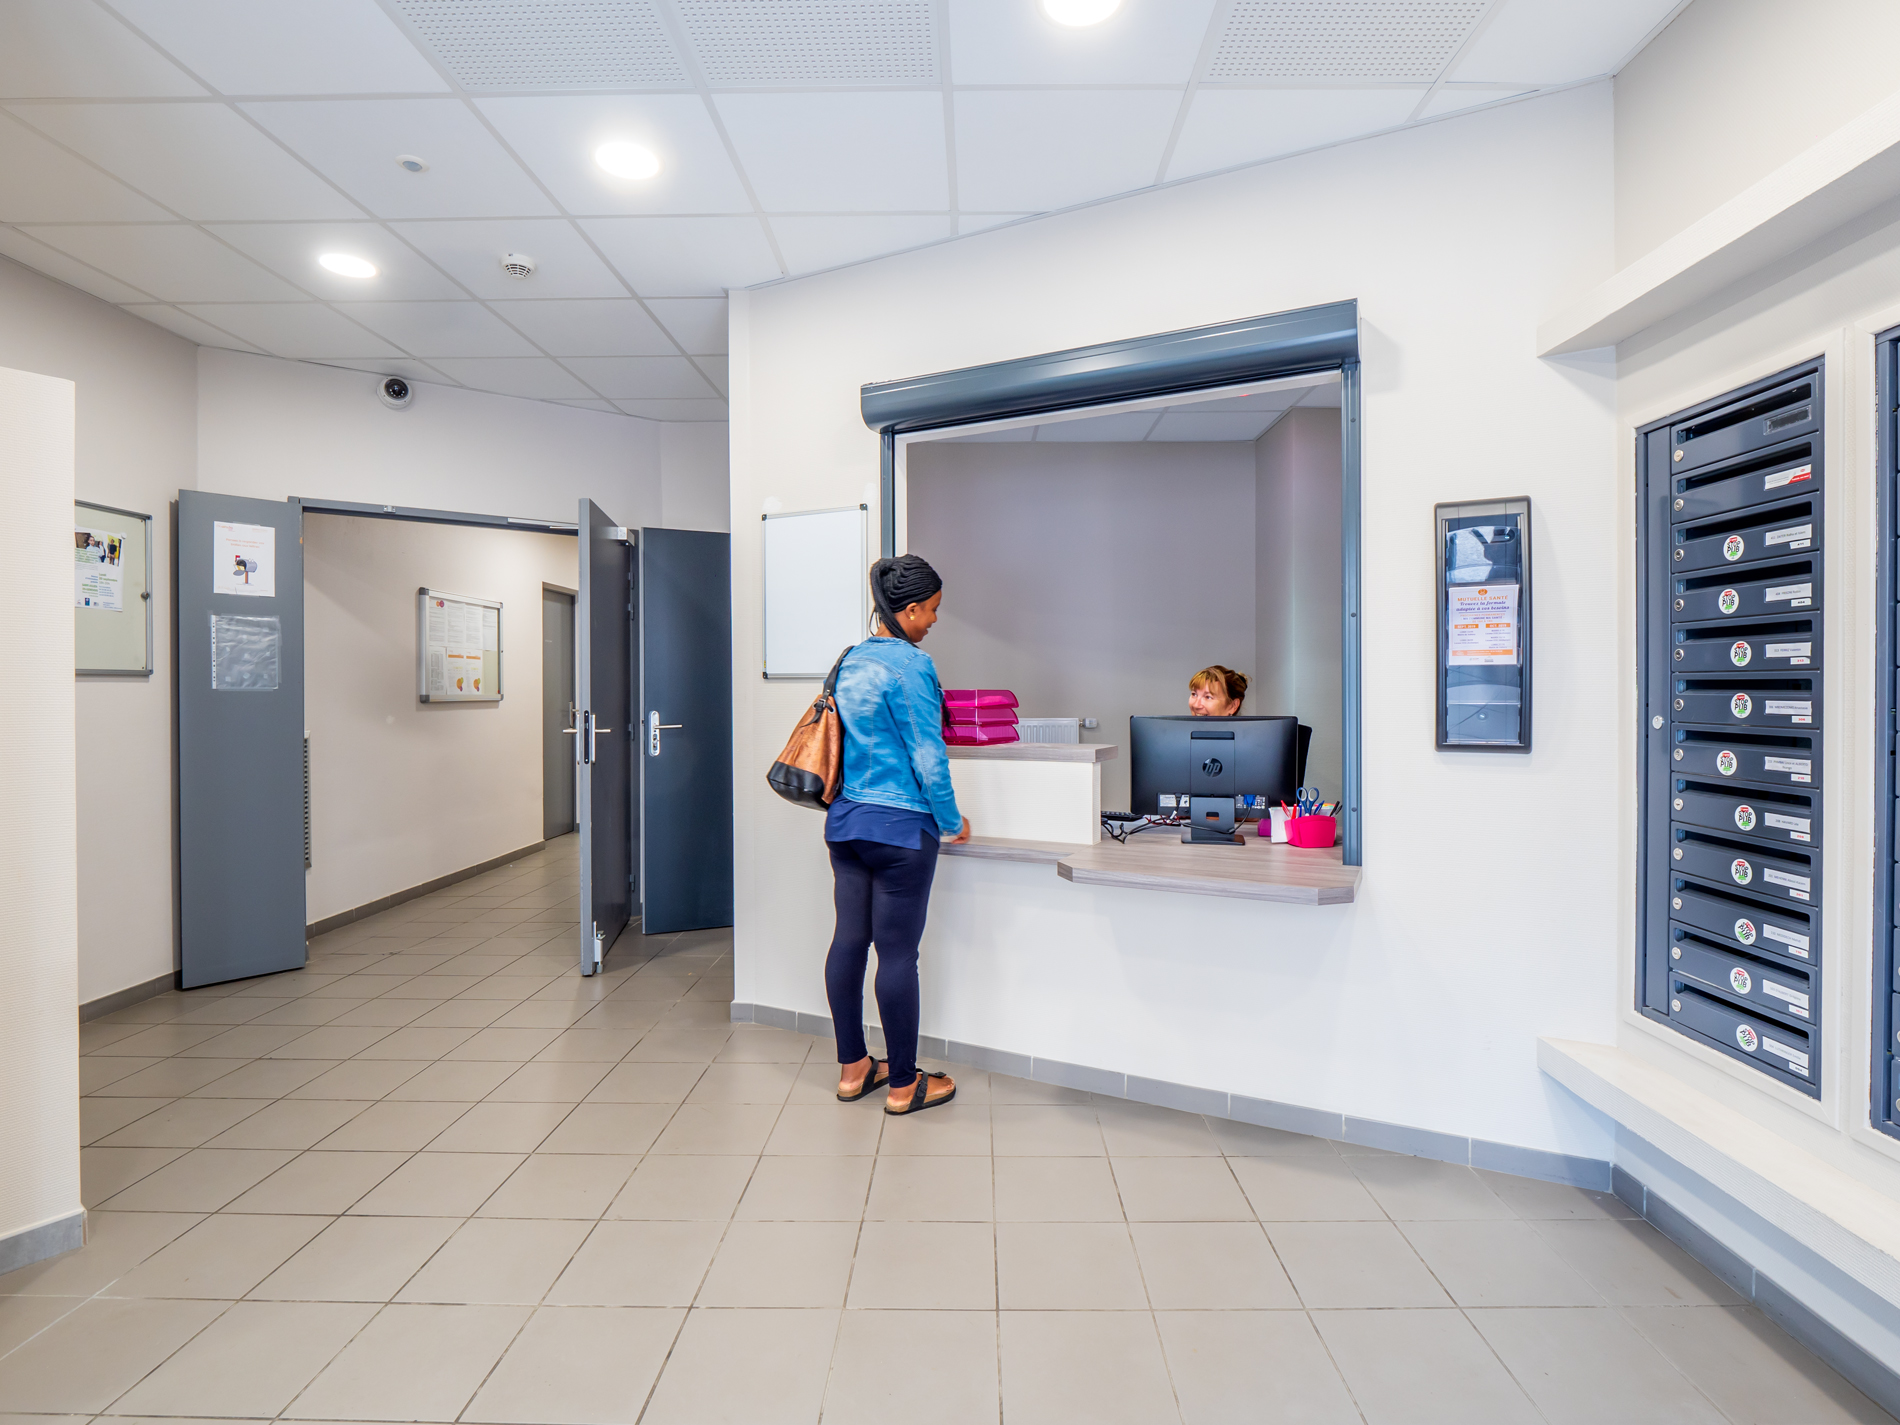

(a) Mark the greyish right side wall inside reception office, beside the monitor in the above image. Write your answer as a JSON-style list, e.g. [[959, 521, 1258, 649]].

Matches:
[[1246, 407, 1343, 796]]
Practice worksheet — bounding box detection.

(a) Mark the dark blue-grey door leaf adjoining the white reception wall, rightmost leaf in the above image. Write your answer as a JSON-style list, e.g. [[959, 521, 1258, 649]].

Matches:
[[638, 530, 732, 935]]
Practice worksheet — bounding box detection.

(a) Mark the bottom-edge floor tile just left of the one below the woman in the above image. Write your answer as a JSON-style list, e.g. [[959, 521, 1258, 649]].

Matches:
[[640, 1311, 838, 1425]]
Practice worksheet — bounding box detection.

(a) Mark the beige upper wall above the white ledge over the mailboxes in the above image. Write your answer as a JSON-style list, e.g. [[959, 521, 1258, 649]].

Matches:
[[1615, 0, 1900, 266]]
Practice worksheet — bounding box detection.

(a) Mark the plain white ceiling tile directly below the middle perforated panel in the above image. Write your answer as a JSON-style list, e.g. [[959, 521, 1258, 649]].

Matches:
[[716, 91, 950, 213]]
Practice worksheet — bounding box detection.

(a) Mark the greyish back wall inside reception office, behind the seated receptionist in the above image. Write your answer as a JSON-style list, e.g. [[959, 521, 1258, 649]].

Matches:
[[904, 441, 1265, 809]]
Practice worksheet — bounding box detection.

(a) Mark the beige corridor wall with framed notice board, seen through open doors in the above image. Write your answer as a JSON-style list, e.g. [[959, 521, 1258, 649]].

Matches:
[[304, 515, 578, 922]]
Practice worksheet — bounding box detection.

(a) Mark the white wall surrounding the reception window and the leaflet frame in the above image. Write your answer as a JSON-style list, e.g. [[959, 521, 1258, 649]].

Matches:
[[732, 84, 1628, 1157]]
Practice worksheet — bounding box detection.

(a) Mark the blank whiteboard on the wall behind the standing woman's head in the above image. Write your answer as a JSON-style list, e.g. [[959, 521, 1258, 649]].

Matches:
[[764, 505, 870, 678]]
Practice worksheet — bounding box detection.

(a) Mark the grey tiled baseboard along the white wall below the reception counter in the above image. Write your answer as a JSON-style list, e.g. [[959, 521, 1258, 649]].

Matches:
[[732, 1003, 1611, 1191]]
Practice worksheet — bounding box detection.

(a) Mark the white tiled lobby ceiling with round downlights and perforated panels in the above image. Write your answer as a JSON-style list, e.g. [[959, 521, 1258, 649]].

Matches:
[[0, 0, 1682, 423]]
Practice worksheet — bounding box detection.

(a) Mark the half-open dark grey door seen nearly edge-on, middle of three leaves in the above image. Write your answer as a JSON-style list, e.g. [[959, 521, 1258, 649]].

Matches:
[[574, 500, 635, 975]]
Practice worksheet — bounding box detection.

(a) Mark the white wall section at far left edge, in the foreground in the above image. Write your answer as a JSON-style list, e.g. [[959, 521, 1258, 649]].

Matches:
[[0, 369, 82, 1271]]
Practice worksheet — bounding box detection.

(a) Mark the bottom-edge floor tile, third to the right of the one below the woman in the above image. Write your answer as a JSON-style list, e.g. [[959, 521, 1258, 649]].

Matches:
[[1311, 1311, 1543, 1425]]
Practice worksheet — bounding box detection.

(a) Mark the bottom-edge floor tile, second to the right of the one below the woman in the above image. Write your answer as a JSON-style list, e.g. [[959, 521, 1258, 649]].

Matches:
[[1155, 1311, 1360, 1425]]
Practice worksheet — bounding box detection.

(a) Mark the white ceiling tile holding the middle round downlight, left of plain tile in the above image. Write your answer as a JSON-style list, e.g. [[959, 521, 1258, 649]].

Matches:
[[479, 93, 752, 213]]
